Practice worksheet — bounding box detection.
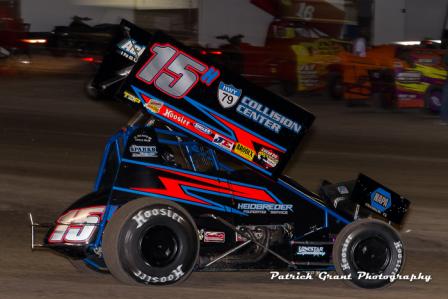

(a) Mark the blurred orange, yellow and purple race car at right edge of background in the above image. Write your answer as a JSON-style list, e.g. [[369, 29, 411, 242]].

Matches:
[[329, 45, 447, 113]]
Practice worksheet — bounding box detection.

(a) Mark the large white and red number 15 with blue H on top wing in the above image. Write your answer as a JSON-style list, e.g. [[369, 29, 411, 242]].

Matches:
[[136, 43, 220, 99]]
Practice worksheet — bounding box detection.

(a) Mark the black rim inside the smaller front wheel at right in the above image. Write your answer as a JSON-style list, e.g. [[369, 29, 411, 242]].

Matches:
[[352, 236, 391, 274]]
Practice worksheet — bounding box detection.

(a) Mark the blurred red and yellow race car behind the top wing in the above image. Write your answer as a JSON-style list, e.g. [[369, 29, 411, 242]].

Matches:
[[201, 19, 347, 95]]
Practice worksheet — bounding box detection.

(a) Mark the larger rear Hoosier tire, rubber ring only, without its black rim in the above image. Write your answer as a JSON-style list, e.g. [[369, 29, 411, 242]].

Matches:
[[104, 198, 199, 285]]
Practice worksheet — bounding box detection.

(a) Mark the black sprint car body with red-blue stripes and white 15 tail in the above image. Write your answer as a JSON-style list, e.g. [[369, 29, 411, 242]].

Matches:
[[45, 120, 351, 269]]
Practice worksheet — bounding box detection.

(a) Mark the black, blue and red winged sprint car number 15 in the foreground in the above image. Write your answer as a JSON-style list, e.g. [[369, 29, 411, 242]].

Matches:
[[30, 21, 410, 288]]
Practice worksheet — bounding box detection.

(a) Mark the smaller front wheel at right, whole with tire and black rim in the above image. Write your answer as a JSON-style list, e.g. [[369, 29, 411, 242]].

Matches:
[[333, 219, 405, 289]]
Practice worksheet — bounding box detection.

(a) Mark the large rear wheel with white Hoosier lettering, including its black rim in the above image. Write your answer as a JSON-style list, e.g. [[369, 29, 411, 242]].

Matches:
[[102, 197, 199, 285]]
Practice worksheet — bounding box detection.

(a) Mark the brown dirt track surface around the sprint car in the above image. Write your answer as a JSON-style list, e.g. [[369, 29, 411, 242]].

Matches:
[[0, 77, 448, 299]]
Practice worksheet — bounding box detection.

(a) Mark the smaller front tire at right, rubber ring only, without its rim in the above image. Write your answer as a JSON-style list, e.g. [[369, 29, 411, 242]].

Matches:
[[333, 220, 405, 288]]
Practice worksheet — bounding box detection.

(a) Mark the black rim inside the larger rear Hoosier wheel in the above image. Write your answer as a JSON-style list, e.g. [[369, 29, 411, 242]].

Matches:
[[140, 225, 179, 268]]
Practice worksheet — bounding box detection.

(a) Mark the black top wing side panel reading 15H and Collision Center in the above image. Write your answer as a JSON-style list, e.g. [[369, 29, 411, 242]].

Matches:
[[118, 32, 314, 178]]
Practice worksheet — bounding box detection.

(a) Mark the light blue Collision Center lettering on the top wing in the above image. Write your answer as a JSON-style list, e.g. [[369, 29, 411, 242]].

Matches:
[[236, 96, 302, 134]]
